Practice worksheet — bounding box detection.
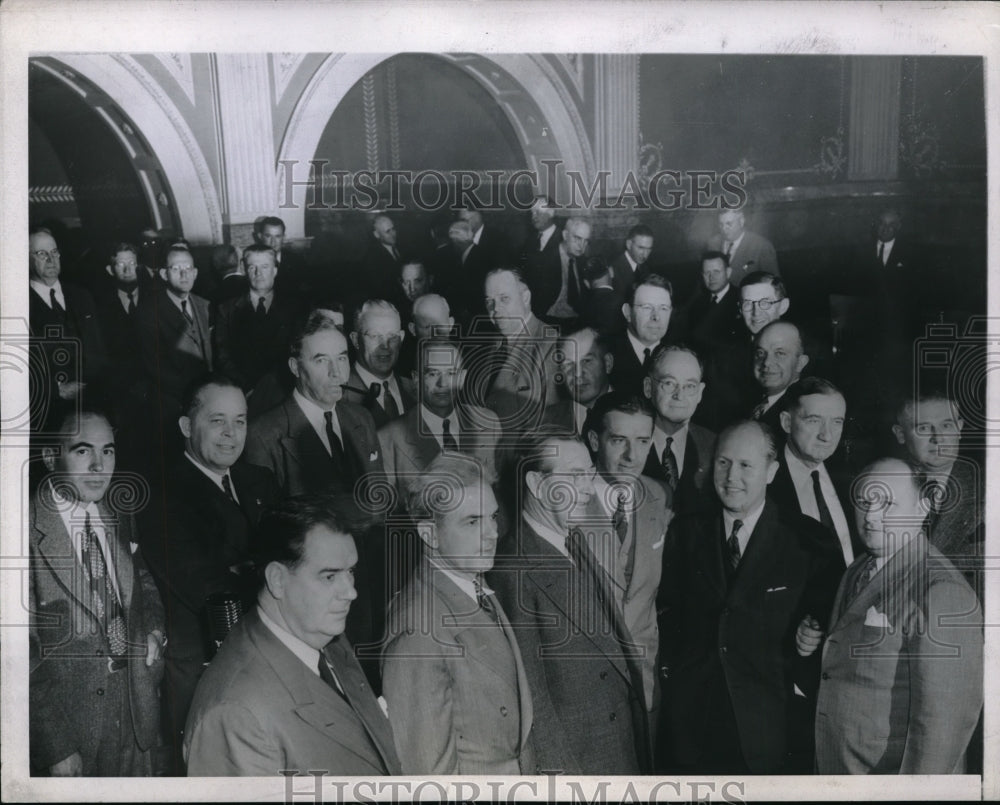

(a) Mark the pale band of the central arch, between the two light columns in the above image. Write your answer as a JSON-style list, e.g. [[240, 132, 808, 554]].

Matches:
[[276, 53, 594, 237]]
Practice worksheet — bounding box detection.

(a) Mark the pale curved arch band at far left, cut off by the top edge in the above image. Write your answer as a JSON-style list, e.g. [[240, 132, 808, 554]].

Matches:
[[48, 53, 223, 243]]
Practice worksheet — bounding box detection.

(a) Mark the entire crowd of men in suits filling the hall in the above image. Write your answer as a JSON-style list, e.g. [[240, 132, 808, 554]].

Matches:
[[29, 197, 985, 776]]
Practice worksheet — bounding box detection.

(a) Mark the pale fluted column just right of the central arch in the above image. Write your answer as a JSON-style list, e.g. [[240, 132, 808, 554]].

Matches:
[[594, 53, 639, 195]]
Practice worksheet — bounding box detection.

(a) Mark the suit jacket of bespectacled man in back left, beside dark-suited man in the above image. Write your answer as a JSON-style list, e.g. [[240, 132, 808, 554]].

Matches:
[[136, 288, 213, 414]]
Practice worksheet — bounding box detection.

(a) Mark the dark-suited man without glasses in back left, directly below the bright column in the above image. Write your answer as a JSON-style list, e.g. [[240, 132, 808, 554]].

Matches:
[[212, 244, 297, 418]]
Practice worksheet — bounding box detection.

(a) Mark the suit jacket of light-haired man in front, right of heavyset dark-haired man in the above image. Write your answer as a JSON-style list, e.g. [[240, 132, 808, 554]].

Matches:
[[382, 563, 535, 775]]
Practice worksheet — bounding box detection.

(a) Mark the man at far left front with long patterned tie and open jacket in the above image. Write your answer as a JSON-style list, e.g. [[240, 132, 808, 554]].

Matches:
[[28, 411, 166, 777]]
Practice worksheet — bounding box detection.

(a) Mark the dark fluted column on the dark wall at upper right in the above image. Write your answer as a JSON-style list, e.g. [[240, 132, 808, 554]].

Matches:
[[847, 56, 903, 181]]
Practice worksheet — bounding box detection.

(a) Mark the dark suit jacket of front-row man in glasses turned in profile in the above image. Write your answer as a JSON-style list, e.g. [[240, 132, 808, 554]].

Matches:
[[489, 523, 649, 775]]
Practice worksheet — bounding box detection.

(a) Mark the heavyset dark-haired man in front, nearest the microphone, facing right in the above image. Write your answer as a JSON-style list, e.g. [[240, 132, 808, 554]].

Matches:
[[184, 497, 401, 777]]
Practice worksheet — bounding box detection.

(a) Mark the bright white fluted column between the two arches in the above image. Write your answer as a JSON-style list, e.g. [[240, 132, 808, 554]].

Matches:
[[214, 53, 278, 246]]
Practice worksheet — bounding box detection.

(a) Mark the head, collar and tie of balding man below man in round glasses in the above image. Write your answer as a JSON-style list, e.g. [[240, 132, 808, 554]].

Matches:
[[748, 321, 809, 435]]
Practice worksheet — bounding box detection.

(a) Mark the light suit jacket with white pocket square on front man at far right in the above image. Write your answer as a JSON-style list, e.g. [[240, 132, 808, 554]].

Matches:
[[816, 534, 983, 774]]
